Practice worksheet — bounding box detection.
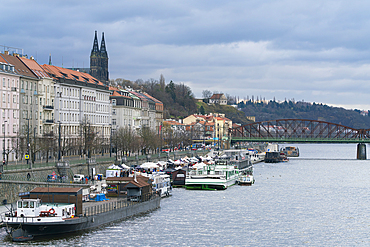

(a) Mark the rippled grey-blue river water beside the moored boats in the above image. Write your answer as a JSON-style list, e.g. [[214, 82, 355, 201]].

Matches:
[[0, 144, 370, 246]]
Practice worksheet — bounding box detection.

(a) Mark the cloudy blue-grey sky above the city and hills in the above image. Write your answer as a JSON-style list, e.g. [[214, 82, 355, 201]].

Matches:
[[0, 0, 370, 110]]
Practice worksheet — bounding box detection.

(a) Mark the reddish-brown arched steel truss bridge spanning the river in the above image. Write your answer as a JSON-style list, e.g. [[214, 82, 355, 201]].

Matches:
[[230, 119, 370, 143]]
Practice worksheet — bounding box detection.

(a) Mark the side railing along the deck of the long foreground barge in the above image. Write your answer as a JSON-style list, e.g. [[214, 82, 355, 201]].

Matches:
[[83, 194, 158, 216]]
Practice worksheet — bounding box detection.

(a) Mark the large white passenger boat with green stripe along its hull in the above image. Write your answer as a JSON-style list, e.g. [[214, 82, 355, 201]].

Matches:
[[185, 160, 239, 190]]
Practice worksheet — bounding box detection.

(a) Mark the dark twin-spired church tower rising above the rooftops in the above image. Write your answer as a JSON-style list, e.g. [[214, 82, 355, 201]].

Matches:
[[90, 31, 109, 85]]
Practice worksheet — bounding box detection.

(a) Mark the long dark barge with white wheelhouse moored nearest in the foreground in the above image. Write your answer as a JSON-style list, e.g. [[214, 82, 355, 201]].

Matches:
[[1, 183, 160, 241]]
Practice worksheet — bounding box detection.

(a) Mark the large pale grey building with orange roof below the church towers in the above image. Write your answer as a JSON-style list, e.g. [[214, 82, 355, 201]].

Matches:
[[42, 65, 111, 155]]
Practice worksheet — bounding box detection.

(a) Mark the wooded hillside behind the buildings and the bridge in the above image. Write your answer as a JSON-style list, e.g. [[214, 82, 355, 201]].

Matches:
[[111, 75, 370, 129]]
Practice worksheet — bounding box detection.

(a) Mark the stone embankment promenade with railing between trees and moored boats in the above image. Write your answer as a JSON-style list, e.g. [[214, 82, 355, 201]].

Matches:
[[0, 150, 209, 204]]
